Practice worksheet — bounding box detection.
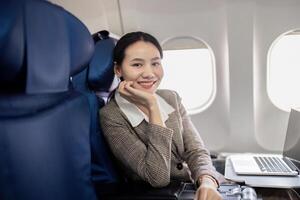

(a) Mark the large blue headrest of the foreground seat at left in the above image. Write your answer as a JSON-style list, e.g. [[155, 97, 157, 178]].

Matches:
[[0, 0, 94, 94]]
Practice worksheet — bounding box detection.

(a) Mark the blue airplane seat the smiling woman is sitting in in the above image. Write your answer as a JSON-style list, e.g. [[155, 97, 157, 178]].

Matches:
[[72, 31, 119, 184]]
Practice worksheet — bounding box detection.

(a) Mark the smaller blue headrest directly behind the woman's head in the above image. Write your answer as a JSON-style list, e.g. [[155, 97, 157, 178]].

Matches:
[[87, 31, 115, 92]]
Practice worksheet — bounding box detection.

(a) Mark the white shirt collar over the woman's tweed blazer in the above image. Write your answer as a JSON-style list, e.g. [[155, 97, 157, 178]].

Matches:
[[115, 91, 175, 127]]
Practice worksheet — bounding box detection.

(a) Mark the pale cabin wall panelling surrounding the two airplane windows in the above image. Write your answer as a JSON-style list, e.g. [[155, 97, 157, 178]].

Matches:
[[51, 0, 300, 152]]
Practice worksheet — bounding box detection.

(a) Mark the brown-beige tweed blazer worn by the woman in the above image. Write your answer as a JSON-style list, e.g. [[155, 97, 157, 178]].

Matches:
[[100, 90, 221, 187]]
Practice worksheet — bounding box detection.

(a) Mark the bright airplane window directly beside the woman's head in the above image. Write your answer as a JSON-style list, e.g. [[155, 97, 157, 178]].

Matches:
[[160, 37, 216, 114]]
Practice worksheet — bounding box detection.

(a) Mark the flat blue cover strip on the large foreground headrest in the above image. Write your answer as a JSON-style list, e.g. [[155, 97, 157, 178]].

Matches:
[[25, 2, 71, 93]]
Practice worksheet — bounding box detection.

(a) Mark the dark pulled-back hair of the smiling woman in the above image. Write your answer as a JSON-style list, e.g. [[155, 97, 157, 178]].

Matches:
[[108, 31, 163, 100]]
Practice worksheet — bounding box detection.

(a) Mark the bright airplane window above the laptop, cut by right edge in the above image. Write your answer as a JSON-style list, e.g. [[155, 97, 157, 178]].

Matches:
[[267, 31, 300, 111]]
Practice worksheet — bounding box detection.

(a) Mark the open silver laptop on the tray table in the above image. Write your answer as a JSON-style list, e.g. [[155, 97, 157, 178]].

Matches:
[[229, 109, 300, 176]]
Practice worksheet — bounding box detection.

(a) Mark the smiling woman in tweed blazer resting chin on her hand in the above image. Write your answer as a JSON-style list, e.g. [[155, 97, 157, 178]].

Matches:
[[100, 32, 221, 200]]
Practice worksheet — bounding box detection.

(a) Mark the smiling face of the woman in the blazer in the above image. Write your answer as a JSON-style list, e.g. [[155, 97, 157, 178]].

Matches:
[[115, 41, 164, 93]]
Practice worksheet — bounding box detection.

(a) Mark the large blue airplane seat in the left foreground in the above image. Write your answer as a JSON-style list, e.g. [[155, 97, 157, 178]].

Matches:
[[0, 0, 97, 200]]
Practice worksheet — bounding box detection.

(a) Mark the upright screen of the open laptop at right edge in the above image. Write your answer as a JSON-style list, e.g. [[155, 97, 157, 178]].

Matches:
[[283, 109, 300, 162]]
